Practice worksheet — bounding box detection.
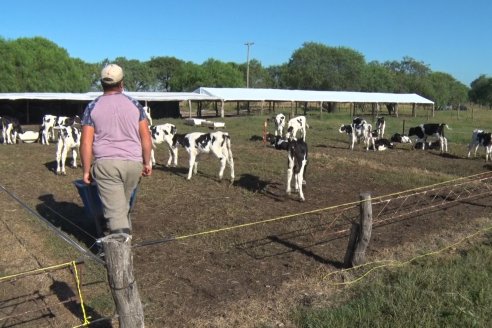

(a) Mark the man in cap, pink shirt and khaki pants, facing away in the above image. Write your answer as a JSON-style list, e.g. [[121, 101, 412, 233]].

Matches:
[[80, 64, 152, 234]]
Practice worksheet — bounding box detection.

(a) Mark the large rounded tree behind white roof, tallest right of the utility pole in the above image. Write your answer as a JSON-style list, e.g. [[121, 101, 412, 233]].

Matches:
[[285, 42, 365, 91]]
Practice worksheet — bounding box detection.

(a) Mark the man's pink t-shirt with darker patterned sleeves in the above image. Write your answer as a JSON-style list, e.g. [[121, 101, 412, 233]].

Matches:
[[82, 93, 146, 162]]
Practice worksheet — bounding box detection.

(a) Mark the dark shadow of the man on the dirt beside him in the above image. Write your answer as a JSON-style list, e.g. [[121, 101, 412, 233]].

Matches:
[[36, 194, 98, 251]]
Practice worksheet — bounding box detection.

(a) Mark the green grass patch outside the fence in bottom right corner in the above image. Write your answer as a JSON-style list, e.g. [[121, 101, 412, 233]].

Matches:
[[294, 234, 492, 328]]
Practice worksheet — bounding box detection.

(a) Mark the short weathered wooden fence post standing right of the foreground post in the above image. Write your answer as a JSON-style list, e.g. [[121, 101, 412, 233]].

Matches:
[[344, 192, 372, 268]]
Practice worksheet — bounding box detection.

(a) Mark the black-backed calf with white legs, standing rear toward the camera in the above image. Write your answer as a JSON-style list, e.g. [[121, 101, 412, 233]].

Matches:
[[286, 139, 308, 201]]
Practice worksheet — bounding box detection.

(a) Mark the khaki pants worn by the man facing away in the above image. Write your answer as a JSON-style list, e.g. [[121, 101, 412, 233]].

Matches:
[[91, 159, 142, 232]]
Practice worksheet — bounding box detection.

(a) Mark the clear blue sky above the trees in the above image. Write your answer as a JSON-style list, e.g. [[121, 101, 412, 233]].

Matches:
[[0, 0, 492, 85]]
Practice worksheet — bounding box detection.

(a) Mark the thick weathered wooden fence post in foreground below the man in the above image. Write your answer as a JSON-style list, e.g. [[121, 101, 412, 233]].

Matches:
[[101, 233, 145, 328]]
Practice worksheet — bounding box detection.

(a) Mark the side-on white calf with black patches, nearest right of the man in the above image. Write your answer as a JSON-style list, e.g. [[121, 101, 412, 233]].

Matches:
[[173, 131, 234, 182]]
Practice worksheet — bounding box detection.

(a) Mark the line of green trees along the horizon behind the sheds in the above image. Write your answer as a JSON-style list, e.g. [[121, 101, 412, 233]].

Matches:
[[0, 37, 492, 108]]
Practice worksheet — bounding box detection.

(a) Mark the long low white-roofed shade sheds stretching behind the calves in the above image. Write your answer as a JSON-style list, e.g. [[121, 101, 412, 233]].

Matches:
[[0, 87, 434, 124]]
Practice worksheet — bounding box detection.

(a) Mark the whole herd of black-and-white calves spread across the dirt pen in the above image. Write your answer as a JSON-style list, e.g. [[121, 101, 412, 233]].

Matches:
[[0, 111, 492, 201]]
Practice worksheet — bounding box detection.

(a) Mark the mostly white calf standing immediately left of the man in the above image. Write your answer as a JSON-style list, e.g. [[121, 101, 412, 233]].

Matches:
[[54, 126, 81, 175]]
